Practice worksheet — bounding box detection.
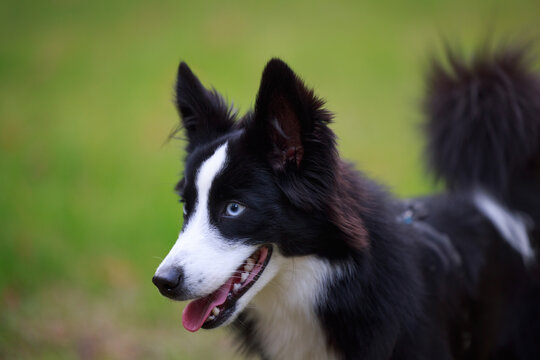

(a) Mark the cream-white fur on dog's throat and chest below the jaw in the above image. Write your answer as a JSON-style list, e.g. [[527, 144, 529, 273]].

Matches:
[[251, 256, 336, 359]]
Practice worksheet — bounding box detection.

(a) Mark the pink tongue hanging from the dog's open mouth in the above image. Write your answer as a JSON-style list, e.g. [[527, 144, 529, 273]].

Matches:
[[182, 277, 233, 332]]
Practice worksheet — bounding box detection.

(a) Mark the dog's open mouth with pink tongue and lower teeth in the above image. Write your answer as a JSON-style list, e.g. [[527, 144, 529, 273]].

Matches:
[[182, 246, 272, 332]]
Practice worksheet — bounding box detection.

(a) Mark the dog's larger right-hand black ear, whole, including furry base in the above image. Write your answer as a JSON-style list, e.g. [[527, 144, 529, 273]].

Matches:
[[245, 59, 338, 210]]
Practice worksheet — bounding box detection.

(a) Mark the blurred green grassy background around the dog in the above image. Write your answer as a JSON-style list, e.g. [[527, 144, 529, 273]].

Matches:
[[0, 0, 540, 359]]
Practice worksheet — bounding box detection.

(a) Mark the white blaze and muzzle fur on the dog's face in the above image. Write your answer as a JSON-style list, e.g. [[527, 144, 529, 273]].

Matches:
[[156, 143, 256, 297]]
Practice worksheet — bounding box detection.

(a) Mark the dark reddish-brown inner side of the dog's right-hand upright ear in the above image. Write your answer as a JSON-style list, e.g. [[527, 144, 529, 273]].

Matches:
[[254, 59, 322, 170]]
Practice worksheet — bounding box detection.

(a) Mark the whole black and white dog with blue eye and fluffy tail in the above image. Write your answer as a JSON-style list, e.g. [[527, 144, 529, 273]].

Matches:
[[153, 48, 540, 360]]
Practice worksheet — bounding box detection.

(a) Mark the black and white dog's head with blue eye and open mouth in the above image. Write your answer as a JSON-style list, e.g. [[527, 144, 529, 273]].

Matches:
[[153, 59, 352, 331]]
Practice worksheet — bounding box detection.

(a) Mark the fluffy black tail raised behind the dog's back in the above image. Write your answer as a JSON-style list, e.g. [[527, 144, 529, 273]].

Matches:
[[425, 46, 540, 198]]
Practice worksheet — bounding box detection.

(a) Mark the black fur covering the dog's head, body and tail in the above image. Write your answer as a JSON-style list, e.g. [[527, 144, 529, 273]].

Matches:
[[163, 48, 540, 360]]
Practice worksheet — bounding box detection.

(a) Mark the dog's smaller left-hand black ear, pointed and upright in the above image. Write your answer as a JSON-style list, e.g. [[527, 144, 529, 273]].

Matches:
[[176, 62, 234, 152]]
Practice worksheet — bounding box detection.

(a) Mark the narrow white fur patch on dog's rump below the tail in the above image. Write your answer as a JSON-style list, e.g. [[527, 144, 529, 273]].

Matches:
[[474, 190, 534, 262]]
